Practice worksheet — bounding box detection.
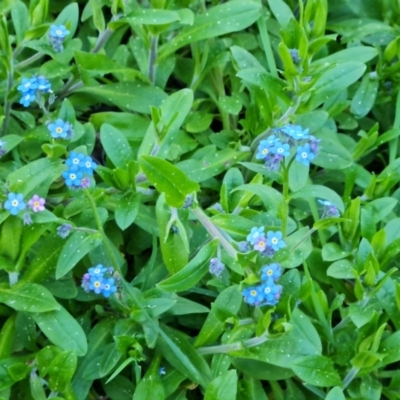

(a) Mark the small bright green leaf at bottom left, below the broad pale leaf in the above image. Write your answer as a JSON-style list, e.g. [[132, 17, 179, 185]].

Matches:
[[48, 350, 77, 392]]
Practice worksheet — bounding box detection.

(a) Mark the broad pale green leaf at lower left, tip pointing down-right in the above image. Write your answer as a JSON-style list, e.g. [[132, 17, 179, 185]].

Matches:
[[32, 306, 87, 356]]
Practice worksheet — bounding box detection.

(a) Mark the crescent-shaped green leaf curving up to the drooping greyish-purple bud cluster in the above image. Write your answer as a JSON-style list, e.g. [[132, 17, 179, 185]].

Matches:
[[157, 239, 218, 292]]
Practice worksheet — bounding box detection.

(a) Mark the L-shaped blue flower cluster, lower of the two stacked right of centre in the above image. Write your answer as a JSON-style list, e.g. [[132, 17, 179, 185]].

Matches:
[[242, 263, 282, 306]]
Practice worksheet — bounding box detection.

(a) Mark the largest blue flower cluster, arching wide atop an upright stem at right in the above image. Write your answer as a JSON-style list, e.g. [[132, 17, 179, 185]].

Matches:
[[256, 125, 319, 171]]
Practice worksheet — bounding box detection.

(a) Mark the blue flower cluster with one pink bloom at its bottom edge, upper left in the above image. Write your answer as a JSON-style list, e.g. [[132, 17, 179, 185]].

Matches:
[[62, 151, 97, 189]]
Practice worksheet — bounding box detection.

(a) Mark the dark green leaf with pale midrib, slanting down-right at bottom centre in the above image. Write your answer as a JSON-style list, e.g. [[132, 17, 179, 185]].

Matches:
[[156, 326, 211, 388]]
